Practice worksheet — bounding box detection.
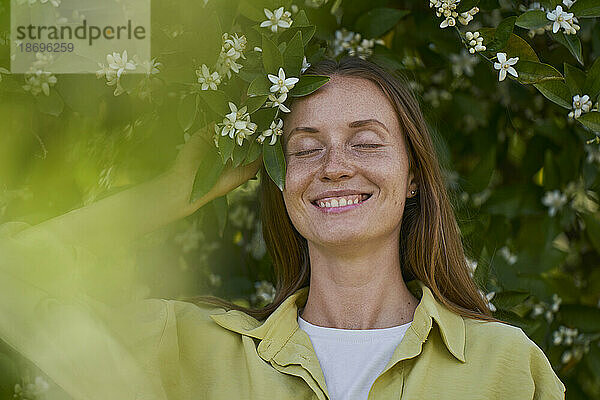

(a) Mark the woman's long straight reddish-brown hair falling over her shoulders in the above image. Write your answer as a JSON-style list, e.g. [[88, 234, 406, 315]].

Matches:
[[195, 57, 503, 322]]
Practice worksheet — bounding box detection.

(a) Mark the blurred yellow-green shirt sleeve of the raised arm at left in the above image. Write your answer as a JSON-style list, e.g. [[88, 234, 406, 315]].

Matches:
[[0, 222, 172, 400]]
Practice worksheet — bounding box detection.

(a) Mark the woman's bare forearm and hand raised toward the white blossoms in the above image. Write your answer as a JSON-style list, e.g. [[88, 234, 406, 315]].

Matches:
[[13, 131, 262, 251]]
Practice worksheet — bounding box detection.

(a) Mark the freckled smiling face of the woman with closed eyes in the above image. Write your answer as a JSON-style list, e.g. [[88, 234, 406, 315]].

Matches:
[[283, 76, 416, 247]]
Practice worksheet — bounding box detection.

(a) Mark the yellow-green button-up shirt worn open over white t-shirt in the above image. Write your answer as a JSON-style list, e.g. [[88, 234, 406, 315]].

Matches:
[[0, 222, 565, 400]]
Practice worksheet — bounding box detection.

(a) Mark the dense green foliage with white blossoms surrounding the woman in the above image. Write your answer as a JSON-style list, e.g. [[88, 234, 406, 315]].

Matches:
[[0, 0, 600, 399]]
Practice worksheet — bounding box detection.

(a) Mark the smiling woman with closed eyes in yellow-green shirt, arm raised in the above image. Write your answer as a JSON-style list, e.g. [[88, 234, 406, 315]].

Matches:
[[0, 58, 565, 399]]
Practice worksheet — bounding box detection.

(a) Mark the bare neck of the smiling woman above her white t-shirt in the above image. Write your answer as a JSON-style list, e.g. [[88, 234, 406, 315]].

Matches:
[[301, 234, 419, 329]]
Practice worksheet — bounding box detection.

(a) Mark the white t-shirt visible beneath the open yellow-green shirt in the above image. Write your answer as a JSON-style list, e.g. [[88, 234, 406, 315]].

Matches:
[[298, 315, 412, 400]]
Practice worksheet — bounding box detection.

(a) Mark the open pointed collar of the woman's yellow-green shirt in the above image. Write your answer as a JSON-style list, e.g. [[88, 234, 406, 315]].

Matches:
[[210, 280, 465, 362]]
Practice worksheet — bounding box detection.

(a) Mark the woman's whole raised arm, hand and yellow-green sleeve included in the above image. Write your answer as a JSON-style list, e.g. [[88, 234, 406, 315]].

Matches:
[[0, 126, 261, 400]]
